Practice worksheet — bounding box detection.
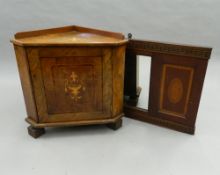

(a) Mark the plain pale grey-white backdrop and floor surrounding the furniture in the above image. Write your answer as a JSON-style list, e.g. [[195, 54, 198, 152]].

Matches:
[[0, 0, 220, 175]]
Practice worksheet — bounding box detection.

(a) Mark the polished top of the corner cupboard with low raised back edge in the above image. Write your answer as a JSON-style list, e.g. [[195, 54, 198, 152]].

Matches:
[[11, 26, 127, 46]]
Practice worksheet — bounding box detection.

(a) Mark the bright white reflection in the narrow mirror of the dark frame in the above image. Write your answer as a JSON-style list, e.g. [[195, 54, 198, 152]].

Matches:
[[137, 55, 151, 109]]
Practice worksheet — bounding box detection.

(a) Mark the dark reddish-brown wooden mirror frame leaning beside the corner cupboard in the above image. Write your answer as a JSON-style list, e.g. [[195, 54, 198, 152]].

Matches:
[[124, 40, 211, 134]]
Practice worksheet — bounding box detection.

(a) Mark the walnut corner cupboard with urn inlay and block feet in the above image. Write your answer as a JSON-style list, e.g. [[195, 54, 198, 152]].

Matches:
[[12, 26, 127, 138]]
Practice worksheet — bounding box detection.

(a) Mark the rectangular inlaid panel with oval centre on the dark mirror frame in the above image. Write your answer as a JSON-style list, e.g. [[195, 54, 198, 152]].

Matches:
[[159, 64, 194, 118]]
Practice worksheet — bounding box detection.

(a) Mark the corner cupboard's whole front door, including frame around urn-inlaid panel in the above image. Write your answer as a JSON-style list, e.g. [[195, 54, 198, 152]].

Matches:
[[28, 47, 112, 122]]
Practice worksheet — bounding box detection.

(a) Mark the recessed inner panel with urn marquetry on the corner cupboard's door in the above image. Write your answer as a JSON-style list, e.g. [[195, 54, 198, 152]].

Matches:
[[40, 57, 102, 115]]
